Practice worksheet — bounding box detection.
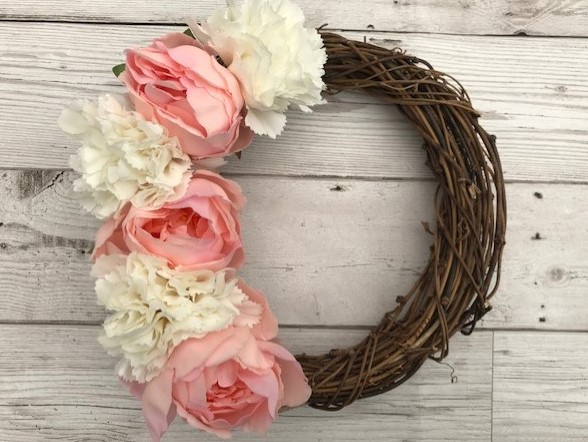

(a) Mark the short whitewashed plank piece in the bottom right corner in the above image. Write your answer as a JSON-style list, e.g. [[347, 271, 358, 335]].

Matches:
[[493, 332, 588, 442]]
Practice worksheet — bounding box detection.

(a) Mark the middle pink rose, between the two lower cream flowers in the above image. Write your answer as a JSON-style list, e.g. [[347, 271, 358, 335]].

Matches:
[[93, 170, 245, 271]]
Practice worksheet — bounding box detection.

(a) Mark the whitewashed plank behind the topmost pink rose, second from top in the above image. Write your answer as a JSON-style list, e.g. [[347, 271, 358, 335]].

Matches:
[[0, 22, 588, 182]]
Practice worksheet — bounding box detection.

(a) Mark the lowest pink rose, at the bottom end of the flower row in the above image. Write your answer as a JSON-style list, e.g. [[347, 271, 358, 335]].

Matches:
[[127, 281, 311, 442]]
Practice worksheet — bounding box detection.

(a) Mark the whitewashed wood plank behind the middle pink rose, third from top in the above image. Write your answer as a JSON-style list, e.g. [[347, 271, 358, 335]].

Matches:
[[0, 171, 588, 330]]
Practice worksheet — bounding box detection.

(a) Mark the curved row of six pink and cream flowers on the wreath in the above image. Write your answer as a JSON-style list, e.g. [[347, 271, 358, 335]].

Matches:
[[59, 0, 326, 441]]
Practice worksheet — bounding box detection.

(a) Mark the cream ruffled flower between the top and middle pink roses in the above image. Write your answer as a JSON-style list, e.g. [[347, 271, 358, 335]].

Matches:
[[59, 95, 191, 218]]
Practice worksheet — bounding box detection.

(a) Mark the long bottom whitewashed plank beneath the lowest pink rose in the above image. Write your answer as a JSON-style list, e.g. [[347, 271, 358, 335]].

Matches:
[[0, 325, 492, 442]]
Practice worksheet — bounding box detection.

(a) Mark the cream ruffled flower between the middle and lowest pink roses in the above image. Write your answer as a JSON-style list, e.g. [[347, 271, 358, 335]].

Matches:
[[93, 253, 262, 382]]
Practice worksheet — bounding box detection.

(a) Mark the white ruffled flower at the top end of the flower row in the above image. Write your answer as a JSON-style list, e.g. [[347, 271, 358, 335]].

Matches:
[[190, 0, 327, 138]]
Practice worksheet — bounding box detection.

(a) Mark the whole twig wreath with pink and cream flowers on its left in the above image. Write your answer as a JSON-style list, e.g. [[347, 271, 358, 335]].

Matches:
[[59, 0, 506, 441]]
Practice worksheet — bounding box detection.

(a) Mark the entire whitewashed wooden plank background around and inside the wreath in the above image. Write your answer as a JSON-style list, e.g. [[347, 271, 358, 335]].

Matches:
[[0, 0, 588, 442]]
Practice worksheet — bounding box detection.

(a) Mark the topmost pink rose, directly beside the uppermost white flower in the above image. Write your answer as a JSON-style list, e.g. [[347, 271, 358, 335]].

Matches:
[[120, 33, 253, 159]]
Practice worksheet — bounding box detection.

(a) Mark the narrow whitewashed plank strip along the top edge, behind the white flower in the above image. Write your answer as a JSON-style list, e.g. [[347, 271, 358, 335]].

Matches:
[[0, 0, 588, 36]]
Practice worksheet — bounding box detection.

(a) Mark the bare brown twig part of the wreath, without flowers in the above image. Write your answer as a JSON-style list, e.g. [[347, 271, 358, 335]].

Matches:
[[297, 30, 506, 411]]
